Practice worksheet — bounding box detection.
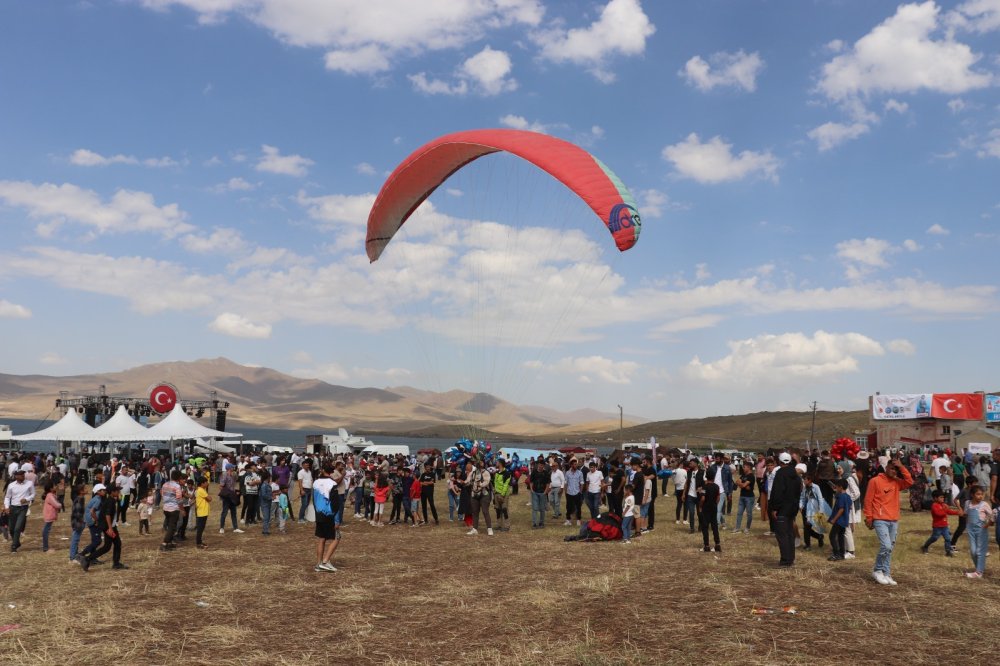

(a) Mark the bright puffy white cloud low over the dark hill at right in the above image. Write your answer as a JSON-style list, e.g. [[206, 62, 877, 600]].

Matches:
[[682, 331, 885, 388]]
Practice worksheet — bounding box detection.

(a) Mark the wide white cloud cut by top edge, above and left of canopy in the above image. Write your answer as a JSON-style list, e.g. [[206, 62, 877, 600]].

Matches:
[[140, 0, 545, 74]]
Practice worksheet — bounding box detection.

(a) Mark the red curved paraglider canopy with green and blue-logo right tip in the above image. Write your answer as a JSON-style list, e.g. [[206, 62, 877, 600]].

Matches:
[[365, 129, 641, 262]]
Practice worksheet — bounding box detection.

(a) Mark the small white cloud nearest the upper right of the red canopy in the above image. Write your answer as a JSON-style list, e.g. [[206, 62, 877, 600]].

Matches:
[[663, 133, 780, 183]]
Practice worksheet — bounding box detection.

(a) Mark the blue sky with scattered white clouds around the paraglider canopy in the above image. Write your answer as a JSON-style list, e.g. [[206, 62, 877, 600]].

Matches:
[[0, 0, 1000, 419]]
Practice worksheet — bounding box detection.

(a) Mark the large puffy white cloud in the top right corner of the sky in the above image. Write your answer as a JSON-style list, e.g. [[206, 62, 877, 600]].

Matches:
[[819, 1, 993, 101]]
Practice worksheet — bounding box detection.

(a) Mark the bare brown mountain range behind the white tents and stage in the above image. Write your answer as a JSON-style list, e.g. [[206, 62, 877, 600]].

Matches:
[[0, 358, 640, 436]]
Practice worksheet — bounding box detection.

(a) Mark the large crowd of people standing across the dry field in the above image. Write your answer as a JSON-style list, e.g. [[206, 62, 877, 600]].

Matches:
[[0, 449, 1000, 585]]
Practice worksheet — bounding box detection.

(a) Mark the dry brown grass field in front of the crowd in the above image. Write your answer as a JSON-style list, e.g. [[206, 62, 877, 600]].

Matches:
[[0, 484, 1000, 666]]
